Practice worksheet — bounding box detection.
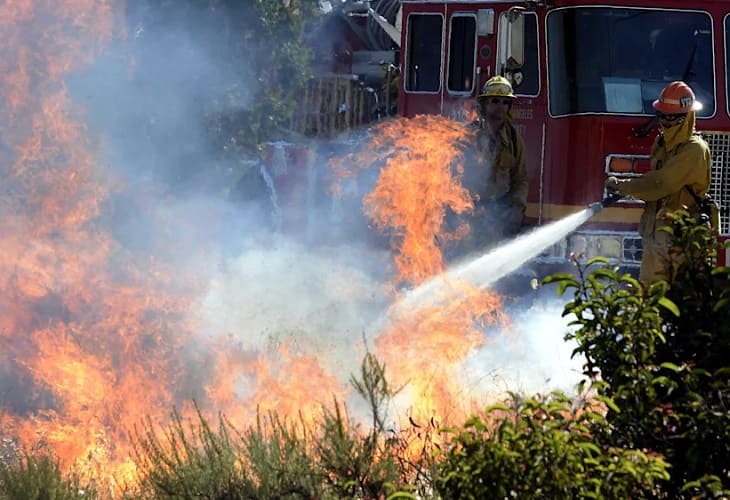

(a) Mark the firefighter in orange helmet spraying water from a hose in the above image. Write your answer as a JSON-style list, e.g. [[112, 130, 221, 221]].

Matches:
[[605, 81, 711, 285]]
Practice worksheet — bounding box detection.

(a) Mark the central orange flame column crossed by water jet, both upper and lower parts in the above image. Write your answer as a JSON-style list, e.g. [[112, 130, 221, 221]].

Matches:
[[333, 115, 507, 428]]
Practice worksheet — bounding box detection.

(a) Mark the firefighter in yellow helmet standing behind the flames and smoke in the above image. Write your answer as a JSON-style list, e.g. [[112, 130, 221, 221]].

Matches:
[[462, 76, 527, 253]]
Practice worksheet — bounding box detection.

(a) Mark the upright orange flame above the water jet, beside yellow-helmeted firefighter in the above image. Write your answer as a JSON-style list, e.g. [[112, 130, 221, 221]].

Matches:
[[334, 115, 474, 284]]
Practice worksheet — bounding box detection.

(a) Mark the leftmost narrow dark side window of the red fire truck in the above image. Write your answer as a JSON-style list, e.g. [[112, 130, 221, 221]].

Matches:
[[405, 14, 443, 92]]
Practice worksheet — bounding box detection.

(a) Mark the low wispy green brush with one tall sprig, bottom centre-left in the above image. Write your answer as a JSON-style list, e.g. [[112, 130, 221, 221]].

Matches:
[[129, 354, 428, 499]]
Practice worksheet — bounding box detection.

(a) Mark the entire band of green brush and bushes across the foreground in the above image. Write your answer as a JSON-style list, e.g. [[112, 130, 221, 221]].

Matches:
[[0, 212, 730, 499]]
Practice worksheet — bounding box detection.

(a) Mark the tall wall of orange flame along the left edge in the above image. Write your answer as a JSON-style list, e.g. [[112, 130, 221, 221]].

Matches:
[[0, 0, 203, 488]]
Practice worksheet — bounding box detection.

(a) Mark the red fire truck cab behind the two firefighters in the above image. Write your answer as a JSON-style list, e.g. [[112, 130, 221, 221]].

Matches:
[[398, 0, 730, 268]]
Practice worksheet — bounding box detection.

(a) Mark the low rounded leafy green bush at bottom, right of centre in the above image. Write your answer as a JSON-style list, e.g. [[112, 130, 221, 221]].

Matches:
[[435, 393, 669, 499]]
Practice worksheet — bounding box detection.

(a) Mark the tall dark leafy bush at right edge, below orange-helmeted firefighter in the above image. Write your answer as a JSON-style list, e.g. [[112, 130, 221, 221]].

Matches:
[[548, 211, 730, 498]]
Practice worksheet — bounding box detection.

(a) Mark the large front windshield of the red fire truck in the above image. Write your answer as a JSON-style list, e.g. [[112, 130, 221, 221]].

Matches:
[[547, 7, 715, 116]]
